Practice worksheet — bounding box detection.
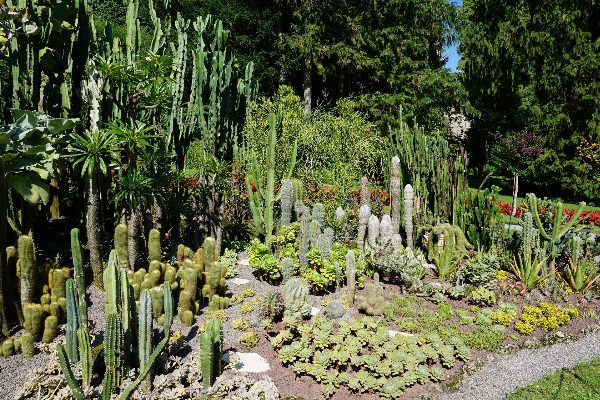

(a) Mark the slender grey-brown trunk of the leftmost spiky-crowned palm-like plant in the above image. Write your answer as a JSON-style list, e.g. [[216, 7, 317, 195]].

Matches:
[[85, 171, 104, 291]]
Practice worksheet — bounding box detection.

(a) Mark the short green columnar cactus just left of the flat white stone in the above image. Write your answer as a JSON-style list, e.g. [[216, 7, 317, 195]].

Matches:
[[200, 319, 223, 388]]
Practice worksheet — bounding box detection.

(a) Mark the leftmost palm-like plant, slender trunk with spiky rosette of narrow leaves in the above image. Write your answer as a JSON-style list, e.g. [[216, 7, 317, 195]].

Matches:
[[68, 130, 118, 290]]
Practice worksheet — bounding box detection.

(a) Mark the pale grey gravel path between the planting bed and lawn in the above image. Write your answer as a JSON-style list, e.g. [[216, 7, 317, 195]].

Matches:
[[437, 332, 600, 400]]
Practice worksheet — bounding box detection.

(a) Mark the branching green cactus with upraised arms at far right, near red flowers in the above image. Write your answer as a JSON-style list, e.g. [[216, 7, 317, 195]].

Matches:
[[527, 193, 585, 273]]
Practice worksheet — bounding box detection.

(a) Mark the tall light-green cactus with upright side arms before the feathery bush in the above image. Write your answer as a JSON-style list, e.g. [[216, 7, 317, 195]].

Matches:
[[246, 111, 297, 248]]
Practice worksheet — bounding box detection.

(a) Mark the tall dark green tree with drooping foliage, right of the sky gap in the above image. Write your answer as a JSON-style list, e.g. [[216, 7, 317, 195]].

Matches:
[[459, 0, 600, 198]]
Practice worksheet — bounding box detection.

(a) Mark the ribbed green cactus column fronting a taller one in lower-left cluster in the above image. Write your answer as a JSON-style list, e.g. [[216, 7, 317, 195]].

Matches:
[[102, 316, 123, 400]]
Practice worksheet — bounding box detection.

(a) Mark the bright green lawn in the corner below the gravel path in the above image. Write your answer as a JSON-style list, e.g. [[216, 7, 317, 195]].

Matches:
[[505, 358, 600, 400]]
